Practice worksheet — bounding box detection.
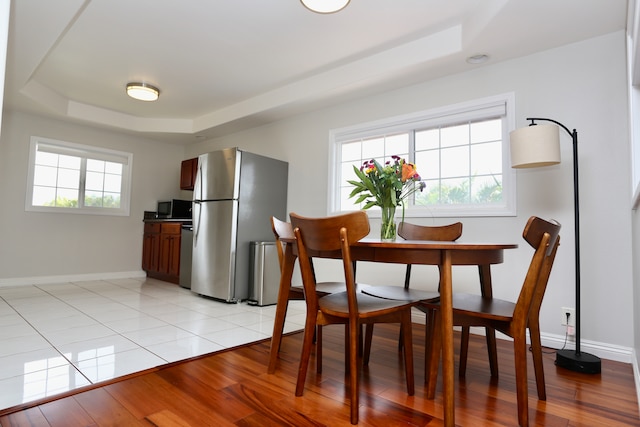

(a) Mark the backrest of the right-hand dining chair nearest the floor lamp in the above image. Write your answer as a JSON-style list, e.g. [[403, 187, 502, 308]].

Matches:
[[513, 216, 561, 327]]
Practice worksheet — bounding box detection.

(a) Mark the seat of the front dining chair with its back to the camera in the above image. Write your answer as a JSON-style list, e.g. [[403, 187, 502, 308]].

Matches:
[[318, 292, 411, 319]]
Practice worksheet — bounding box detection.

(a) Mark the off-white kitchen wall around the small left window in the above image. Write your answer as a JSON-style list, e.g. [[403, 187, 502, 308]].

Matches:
[[0, 112, 184, 285]]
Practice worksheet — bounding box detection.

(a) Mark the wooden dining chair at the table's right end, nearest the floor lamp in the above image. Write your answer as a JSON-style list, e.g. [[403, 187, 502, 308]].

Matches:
[[426, 216, 560, 426]]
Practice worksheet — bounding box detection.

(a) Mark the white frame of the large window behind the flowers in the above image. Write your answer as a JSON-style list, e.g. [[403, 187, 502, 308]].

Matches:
[[327, 92, 516, 218]]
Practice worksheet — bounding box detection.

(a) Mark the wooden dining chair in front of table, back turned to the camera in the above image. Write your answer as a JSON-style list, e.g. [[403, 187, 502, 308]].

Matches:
[[290, 211, 414, 424]]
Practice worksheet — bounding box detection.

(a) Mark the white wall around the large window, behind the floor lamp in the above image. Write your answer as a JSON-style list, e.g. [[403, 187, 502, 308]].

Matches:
[[186, 32, 634, 361]]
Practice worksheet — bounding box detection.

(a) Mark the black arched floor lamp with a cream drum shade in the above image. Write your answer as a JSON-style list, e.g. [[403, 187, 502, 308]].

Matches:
[[509, 118, 601, 374]]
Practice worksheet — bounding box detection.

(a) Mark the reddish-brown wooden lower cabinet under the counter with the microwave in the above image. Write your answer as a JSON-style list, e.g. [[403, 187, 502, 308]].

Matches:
[[142, 222, 182, 284]]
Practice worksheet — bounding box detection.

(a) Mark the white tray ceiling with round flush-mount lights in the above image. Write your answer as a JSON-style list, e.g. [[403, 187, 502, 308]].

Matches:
[[4, 0, 627, 144]]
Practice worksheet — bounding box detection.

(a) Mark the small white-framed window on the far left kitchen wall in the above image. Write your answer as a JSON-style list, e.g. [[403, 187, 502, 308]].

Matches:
[[26, 137, 133, 215]]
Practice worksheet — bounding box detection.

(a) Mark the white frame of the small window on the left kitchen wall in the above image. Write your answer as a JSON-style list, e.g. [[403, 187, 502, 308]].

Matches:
[[25, 136, 133, 216]]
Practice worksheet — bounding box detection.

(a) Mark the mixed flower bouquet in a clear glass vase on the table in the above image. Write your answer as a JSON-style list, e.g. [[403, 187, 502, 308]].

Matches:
[[347, 156, 425, 241]]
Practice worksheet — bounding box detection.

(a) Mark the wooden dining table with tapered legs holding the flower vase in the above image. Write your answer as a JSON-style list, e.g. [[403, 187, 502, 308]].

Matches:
[[267, 237, 518, 426]]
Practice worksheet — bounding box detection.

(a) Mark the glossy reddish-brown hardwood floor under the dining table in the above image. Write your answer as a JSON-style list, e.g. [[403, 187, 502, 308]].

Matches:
[[0, 325, 640, 427]]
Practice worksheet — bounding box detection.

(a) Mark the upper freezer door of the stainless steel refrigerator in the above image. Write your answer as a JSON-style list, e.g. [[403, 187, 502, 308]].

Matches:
[[193, 148, 240, 200]]
